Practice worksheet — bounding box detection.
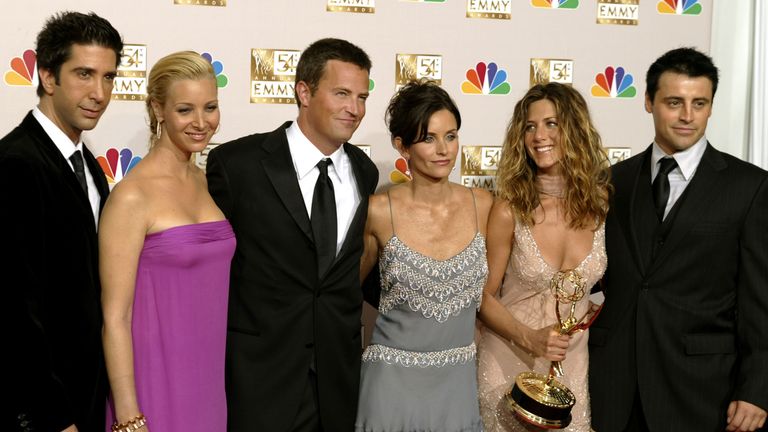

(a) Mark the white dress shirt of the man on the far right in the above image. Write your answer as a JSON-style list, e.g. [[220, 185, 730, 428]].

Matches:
[[651, 136, 707, 217]]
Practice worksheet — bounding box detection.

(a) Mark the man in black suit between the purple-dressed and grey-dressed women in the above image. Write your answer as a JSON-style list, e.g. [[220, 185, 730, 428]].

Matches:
[[207, 39, 378, 432]]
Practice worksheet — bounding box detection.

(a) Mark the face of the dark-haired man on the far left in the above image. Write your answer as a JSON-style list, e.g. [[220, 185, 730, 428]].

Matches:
[[39, 44, 117, 143]]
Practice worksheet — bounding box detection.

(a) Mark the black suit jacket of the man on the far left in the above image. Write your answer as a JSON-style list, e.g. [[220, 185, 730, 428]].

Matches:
[[0, 113, 109, 431]]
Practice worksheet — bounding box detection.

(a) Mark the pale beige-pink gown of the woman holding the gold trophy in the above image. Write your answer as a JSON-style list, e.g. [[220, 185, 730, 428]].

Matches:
[[478, 220, 607, 432]]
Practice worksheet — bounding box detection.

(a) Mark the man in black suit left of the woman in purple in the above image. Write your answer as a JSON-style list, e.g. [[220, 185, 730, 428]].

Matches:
[[0, 12, 123, 431]]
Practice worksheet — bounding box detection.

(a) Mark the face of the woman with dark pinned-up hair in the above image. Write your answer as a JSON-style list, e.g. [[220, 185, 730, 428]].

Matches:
[[395, 109, 459, 180]]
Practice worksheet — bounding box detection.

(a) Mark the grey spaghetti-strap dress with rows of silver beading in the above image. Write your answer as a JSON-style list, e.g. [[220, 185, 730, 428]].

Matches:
[[356, 197, 488, 432]]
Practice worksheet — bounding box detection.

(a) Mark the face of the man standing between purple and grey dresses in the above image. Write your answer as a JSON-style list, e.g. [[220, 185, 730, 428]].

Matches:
[[296, 60, 368, 155]]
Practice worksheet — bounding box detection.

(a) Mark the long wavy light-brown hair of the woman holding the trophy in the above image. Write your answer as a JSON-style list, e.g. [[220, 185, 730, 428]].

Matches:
[[496, 83, 612, 229]]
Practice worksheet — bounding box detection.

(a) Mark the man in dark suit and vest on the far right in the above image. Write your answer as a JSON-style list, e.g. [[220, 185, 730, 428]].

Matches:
[[589, 48, 768, 432]]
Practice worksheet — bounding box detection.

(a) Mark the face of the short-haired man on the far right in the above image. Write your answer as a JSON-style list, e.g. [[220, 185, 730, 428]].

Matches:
[[645, 72, 713, 155]]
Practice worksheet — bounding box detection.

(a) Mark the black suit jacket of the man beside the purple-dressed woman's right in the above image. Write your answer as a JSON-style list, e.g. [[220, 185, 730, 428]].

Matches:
[[207, 122, 378, 432]]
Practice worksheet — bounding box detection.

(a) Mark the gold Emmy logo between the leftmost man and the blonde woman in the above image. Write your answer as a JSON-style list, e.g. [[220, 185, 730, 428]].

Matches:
[[112, 44, 147, 101]]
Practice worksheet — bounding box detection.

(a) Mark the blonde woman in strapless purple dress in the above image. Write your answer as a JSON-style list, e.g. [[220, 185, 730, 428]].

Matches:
[[99, 51, 235, 432]]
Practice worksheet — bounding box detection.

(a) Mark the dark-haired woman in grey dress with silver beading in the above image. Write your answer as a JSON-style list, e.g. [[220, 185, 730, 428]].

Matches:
[[355, 81, 492, 432]]
